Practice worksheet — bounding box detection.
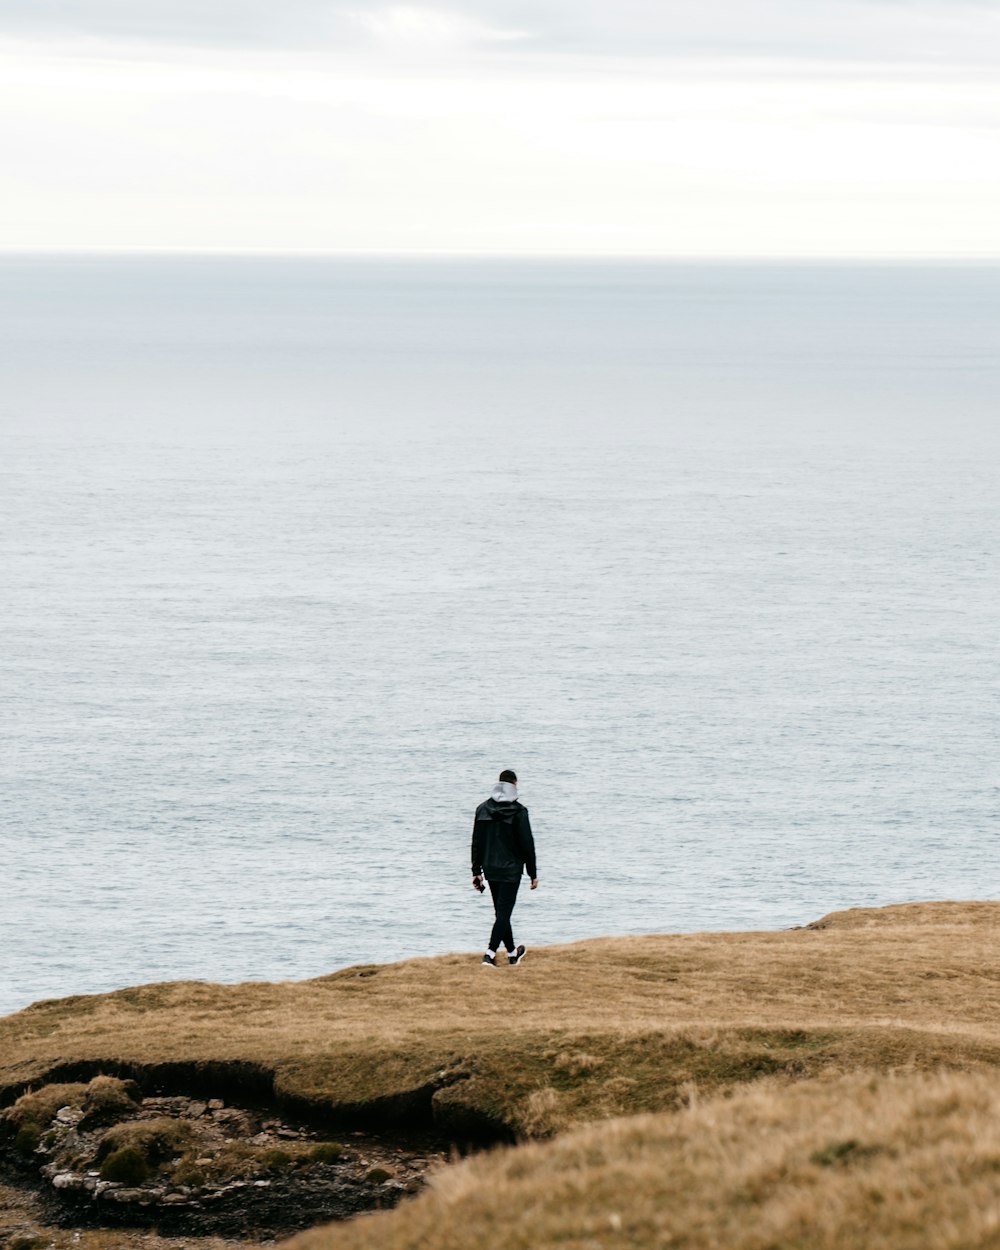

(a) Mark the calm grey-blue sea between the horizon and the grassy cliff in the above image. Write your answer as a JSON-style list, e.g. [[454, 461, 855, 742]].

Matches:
[[0, 258, 1000, 1011]]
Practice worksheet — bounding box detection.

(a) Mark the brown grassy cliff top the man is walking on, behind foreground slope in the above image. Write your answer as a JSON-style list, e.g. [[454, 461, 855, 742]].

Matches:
[[0, 903, 1000, 1136]]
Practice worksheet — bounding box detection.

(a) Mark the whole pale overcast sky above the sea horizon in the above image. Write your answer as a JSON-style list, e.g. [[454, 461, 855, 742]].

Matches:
[[0, 0, 1000, 256]]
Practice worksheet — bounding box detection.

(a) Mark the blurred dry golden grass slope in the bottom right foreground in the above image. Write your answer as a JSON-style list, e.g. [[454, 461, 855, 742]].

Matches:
[[288, 1074, 1000, 1250]]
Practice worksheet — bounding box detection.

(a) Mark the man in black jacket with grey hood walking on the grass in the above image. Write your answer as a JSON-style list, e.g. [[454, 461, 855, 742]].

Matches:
[[473, 769, 539, 968]]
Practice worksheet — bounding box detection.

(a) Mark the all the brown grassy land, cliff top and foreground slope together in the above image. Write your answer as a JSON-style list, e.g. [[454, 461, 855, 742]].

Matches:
[[0, 903, 1000, 1250]]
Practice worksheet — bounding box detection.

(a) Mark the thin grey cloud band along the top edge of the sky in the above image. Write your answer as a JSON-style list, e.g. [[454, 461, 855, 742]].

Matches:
[[0, 0, 1000, 64]]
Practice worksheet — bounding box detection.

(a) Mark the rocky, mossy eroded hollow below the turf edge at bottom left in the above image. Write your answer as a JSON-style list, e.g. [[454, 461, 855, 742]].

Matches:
[[0, 1076, 445, 1248]]
